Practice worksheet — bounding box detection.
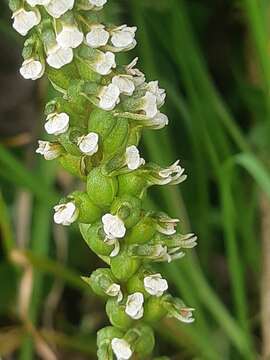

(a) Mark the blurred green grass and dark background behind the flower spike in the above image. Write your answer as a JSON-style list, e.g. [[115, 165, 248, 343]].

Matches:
[[0, 0, 270, 360]]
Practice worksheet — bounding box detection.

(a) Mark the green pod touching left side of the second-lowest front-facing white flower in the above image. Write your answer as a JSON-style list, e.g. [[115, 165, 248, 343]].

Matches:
[[106, 298, 133, 330]]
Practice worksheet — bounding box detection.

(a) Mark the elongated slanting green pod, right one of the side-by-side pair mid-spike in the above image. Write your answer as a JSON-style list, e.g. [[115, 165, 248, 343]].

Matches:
[[103, 118, 129, 158]]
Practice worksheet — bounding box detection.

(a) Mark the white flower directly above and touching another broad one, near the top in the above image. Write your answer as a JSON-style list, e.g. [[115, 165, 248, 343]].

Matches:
[[56, 25, 83, 49]]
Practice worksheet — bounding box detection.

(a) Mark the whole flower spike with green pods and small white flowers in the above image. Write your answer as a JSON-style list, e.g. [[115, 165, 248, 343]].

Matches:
[[10, 0, 197, 360]]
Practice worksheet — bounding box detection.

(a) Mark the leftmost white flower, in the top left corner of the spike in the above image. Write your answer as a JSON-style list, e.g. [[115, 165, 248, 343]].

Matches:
[[12, 8, 41, 36]]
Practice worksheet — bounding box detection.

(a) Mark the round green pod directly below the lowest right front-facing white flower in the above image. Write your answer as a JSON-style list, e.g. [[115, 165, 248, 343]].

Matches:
[[143, 296, 167, 324]]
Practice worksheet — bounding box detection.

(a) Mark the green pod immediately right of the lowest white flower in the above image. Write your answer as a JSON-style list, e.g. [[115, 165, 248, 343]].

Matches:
[[124, 325, 155, 359]]
